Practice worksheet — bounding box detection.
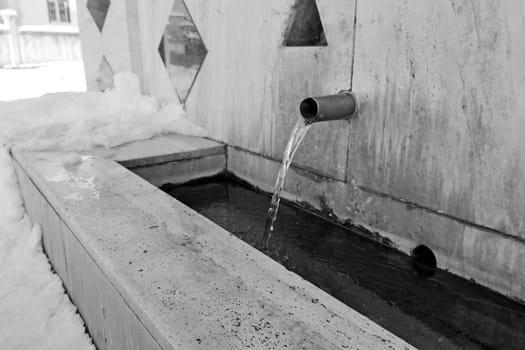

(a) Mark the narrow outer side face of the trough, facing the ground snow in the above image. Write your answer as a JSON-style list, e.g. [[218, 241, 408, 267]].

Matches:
[[15, 159, 161, 350]]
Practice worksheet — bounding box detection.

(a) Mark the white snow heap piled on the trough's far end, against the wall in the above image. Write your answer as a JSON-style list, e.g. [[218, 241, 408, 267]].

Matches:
[[0, 73, 207, 151]]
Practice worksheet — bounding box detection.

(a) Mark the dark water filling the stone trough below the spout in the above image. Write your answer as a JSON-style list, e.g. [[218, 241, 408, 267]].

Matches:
[[163, 178, 525, 350]]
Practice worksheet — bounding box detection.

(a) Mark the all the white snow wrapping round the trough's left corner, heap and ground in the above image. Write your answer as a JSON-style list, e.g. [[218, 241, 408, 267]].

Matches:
[[0, 69, 207, 350]]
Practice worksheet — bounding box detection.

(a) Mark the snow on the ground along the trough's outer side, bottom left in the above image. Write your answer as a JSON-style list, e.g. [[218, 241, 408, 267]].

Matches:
[[0, 147, 94, 350]]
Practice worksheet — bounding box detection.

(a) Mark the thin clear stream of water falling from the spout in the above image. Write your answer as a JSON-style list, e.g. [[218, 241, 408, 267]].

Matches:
[[261, 117, 312, 250]]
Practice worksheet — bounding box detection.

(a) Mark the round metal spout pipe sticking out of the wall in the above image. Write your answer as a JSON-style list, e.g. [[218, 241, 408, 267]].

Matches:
[[299, 90, 359, 123]]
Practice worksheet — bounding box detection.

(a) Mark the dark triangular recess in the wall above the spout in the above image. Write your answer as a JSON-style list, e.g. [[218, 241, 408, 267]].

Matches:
[[284, 0, 328, 46]]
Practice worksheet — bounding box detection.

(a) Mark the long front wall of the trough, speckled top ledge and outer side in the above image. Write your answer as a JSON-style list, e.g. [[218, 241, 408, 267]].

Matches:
[[14, 135, 412, 349]]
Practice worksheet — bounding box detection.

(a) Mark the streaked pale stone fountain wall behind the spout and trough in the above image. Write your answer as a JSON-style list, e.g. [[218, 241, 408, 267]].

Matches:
[[81, 0, 525, 299]]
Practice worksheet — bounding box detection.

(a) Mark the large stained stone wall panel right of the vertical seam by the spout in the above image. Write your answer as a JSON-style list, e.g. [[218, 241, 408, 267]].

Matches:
[[348, 0, 525, 241]]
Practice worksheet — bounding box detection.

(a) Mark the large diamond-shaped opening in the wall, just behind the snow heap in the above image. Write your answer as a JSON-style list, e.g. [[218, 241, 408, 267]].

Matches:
[[158, 0, 208, 103]]
